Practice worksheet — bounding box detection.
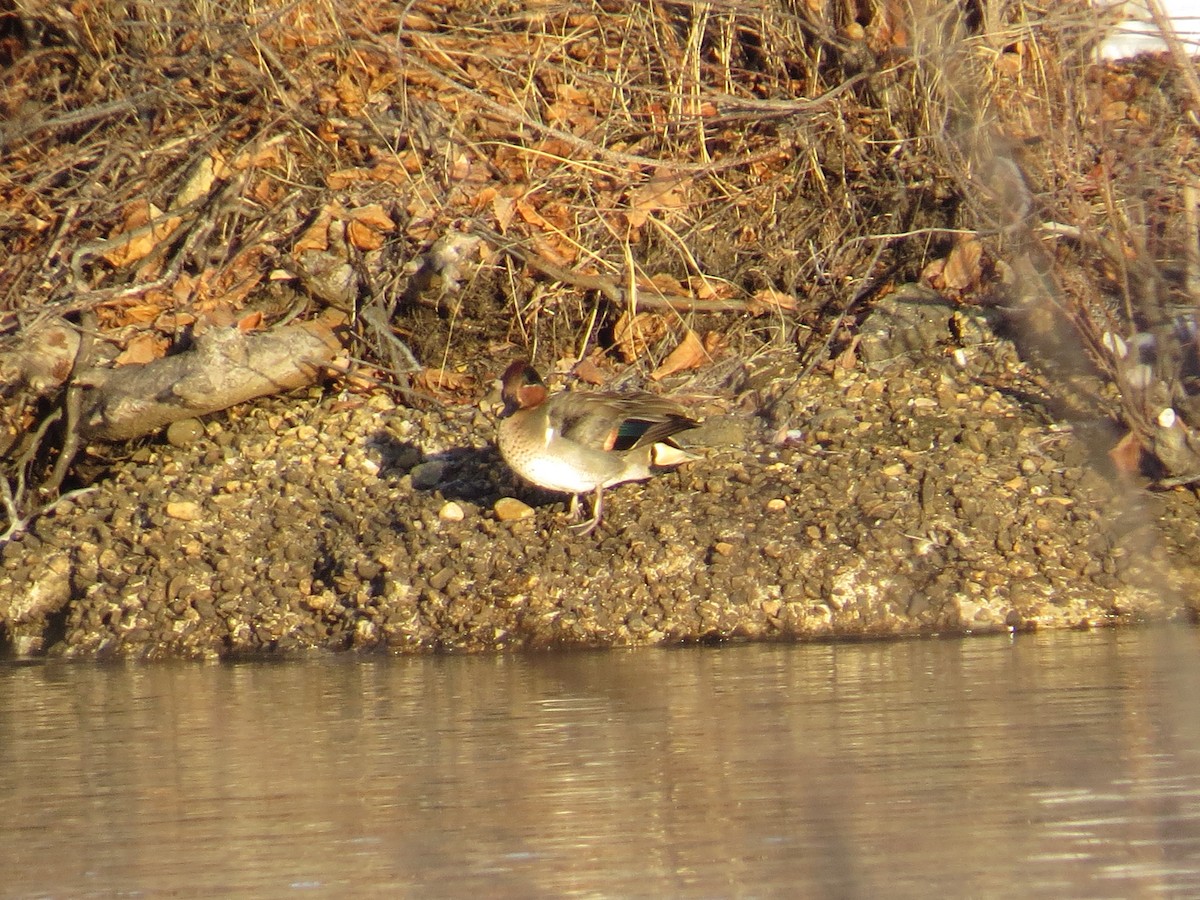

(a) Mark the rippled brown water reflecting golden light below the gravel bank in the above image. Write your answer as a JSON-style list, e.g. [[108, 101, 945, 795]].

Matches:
[[0, 630, 1200, 896]]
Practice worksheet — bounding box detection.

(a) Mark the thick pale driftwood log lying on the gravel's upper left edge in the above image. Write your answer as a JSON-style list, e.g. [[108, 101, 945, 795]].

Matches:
[[80, 322, 342, 440]]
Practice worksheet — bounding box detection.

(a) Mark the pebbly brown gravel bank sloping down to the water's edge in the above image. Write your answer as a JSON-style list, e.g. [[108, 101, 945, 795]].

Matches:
[[0, 307, 1200, 656]]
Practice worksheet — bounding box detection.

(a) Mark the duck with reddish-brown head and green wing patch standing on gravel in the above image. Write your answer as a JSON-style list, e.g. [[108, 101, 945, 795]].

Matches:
[[496, 359, 700, 534]]
